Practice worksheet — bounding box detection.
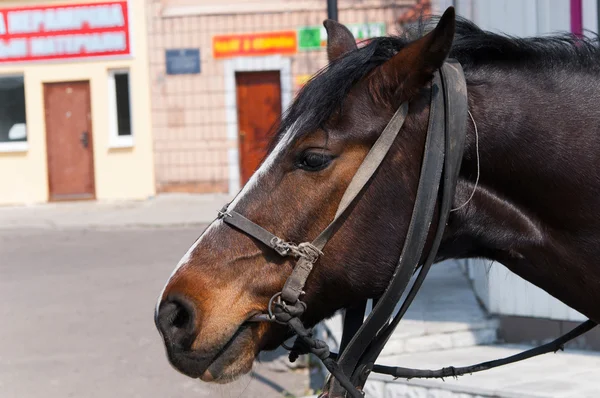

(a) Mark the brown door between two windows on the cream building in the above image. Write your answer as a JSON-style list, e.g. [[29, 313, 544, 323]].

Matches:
[[44, 82, 95, 200]]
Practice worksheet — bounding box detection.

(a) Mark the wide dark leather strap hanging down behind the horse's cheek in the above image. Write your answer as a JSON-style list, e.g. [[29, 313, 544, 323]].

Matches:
[[333, 60, 468, 396]]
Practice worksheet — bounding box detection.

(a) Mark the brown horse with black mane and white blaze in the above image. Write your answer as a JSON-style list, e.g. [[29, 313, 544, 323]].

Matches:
[[155, 8, 600, 394]]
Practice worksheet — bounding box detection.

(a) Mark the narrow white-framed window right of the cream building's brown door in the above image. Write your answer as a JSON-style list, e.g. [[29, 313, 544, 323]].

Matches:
[[108, 70, 133, 148]]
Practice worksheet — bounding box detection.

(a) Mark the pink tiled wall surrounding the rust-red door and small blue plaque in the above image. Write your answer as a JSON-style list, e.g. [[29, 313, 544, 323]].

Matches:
[[146, 0, 416, 193]]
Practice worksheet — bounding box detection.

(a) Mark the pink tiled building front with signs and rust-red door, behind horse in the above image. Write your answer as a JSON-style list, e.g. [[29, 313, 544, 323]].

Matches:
[[146, 0, 423, 195]]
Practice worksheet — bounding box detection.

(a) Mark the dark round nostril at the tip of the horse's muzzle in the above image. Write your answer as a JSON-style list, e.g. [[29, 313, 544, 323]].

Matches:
[[155, 298, 195, 349]]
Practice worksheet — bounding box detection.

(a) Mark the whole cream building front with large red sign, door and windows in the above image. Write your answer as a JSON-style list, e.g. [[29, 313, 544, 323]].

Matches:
[[0, 0, 154, 205]]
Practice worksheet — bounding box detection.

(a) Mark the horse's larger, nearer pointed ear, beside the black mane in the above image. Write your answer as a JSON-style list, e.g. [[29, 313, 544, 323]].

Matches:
[[380, 7, 456, 98]]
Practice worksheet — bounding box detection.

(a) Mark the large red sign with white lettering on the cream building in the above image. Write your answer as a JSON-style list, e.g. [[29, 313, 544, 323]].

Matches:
[[0, 1, 131, 63]]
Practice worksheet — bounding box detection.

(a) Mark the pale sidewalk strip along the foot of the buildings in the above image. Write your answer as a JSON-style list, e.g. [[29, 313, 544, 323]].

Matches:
[[0, 194, 231, 229]]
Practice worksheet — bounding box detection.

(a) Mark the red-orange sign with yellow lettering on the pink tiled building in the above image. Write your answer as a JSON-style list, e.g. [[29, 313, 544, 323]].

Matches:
[[213, 30, 298, 58]]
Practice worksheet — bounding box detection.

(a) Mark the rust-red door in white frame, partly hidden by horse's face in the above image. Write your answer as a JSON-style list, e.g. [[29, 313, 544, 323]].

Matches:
[[235, 71, 281, 185]]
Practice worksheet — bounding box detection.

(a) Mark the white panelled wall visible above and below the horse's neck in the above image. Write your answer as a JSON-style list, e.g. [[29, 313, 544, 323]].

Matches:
[[439, 0, 584, 321]]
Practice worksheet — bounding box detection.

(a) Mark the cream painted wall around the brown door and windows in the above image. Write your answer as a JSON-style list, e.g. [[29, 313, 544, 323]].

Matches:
[[0, 0, 155, 204]]
